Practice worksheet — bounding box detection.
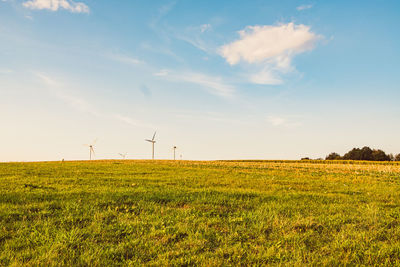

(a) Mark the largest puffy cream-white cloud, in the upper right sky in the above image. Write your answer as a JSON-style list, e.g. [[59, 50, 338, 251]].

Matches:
[[219, 23, 321, 84]]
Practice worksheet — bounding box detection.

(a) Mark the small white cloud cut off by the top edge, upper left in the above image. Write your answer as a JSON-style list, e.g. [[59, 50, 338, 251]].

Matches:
[[22, 0, 90, 13]]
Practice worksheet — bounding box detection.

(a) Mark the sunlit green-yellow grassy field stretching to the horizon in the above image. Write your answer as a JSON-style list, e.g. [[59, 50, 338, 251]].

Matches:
[[0, 161, 400, 266]]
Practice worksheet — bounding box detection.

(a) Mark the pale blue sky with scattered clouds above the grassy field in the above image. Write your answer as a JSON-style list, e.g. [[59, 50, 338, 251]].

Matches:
[[0, 0, 400, 161]]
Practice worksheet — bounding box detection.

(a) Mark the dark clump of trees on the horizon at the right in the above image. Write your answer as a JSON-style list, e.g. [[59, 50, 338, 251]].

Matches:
[[325, 146, 400, 161]]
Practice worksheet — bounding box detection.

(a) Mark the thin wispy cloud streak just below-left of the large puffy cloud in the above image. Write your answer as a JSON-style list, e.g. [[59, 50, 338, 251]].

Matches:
[[154, 70, 235, 98]]
